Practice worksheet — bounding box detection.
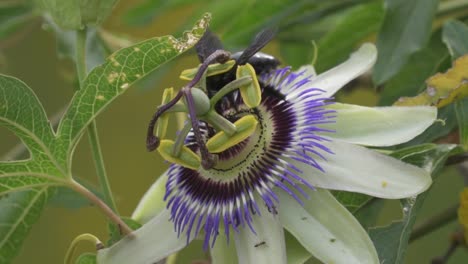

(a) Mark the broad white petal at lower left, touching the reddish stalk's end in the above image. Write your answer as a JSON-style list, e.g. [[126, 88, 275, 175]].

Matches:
[[97, 210, 193, 264]]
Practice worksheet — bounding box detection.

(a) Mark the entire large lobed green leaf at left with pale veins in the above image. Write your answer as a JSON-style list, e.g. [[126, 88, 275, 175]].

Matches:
[[0, 15, 210, 263]]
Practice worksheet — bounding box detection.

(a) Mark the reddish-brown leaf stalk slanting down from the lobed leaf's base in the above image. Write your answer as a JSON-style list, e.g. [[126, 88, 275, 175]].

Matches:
[[68, 180, 132, 235]]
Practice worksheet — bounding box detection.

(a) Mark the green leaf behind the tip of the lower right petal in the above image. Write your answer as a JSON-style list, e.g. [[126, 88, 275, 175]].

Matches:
[[369, 144, 459, 263]]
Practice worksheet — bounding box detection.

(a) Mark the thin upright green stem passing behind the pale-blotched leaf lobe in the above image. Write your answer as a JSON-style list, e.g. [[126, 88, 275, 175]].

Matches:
[[76, 28, 118, 213]]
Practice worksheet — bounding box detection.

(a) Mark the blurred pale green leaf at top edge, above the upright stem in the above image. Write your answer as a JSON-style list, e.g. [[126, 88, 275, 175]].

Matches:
[[34, 0, 117, 29]]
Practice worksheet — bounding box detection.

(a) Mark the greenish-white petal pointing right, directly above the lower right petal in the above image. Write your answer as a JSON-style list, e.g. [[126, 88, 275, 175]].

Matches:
[[321, 103, 437, 146]]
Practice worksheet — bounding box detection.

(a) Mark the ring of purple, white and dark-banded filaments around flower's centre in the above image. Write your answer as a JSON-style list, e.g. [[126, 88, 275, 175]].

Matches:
[[164, 68, 335, 249]]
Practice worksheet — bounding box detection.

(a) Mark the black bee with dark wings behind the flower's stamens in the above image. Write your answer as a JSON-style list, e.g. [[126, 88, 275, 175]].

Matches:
[[195, 28, 280, 107]]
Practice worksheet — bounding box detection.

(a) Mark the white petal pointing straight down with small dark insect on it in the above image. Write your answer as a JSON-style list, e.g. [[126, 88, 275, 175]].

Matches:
[[234, 202, 286, 264]]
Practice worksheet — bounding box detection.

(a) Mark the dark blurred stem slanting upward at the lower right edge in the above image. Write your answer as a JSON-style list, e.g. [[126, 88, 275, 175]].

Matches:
[[409, 204, 459, 242]]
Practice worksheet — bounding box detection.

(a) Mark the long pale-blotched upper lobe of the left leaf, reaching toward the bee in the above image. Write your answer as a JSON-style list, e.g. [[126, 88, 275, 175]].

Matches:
[[56, 14, 211, 170]]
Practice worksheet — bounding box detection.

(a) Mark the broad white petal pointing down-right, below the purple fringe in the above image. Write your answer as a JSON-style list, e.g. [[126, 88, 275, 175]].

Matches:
[[278, 189, 379, 264]]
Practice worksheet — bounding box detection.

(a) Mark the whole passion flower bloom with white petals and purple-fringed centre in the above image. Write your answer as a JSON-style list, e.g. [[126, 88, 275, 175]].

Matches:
[[98, 44, 437, 264]]
